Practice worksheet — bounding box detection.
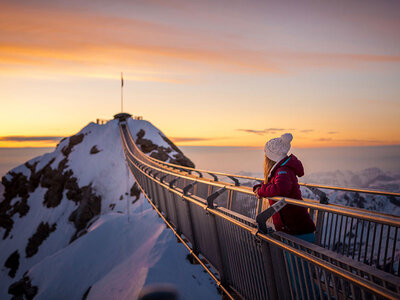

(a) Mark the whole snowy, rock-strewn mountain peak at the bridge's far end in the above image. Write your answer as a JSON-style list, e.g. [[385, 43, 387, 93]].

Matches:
[[0, 119, 220, 299]]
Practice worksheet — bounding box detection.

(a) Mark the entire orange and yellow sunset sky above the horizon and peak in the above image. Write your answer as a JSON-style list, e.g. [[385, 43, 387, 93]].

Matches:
[[0, 0, 400, 147]]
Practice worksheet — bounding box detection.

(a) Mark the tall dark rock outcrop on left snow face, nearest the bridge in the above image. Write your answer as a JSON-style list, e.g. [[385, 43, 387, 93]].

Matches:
[[67, 182, 101, 242]]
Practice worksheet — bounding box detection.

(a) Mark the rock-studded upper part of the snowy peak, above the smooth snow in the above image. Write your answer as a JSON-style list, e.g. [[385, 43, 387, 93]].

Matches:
[[0, 119, 206, 299]]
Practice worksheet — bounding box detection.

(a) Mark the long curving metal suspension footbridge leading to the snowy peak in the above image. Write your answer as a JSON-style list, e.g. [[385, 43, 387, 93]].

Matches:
[[115, 115, 400, 299]]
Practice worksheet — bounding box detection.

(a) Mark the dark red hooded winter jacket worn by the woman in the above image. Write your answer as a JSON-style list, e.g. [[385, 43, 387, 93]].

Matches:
[[258, 154, 315, 235]]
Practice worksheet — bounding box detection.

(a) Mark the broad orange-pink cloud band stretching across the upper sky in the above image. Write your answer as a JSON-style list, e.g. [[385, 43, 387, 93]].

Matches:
[[0, 3, 400, 82]]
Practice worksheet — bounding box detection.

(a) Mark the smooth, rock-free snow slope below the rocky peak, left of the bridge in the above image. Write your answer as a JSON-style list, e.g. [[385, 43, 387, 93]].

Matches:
[[29, 198, 220, 299]]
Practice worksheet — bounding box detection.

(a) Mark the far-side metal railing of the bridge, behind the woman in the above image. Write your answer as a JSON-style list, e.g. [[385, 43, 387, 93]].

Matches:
[[125, 122, 400, 276]]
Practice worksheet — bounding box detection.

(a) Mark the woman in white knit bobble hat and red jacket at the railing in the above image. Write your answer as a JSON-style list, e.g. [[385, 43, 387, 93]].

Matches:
[[253, 133, 315, 243]]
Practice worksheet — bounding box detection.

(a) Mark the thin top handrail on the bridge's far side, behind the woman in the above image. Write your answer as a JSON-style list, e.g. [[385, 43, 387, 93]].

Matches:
[[123, 131, 400, 197]]
